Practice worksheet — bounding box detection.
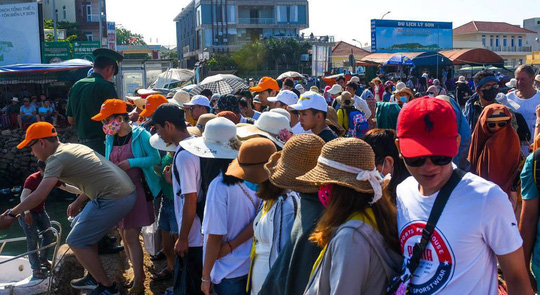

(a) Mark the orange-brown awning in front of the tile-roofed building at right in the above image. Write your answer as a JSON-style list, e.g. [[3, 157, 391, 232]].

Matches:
[[440, 48, 504, 66]]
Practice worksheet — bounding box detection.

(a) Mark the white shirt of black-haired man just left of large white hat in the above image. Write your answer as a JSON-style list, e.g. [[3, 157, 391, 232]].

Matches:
[[172, 142, 203, 247]]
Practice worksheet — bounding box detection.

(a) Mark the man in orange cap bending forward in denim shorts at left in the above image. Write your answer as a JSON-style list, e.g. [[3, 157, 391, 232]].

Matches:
[[6, 122, 137, 294]]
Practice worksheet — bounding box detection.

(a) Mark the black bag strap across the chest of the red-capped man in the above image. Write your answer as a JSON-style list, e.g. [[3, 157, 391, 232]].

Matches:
[[407, 168, 466, 276]]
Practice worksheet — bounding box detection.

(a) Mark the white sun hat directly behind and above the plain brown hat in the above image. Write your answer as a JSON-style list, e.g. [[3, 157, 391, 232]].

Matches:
[[237, 112, 292, 148]]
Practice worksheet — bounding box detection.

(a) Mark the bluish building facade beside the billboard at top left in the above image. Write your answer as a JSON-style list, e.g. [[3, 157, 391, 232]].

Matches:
[[43, 0, 107, 41]]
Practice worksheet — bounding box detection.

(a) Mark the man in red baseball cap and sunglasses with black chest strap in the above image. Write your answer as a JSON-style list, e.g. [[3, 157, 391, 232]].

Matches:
[[396, 97, 533, 294]]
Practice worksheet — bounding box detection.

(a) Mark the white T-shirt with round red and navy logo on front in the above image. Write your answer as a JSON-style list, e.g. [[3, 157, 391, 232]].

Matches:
[[396, 173, 523, 294]]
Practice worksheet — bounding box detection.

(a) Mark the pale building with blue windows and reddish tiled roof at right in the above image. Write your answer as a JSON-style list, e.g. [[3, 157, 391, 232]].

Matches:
[[453, 21, 536, 68]]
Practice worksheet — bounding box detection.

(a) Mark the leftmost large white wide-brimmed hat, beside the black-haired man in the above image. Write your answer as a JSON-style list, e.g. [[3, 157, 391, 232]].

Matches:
[[180, 117, 240, 159]]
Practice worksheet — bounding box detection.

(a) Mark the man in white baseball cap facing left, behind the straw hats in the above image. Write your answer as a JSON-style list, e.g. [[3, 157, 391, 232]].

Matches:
[[288, 91, 338, 142]]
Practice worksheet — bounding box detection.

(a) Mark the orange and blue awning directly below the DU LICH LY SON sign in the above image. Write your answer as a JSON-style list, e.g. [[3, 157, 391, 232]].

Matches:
[[360, 51, 452, 67]]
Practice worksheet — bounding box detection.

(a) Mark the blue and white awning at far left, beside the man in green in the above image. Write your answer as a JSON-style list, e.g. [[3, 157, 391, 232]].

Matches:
[[0, 59, 92, 84]]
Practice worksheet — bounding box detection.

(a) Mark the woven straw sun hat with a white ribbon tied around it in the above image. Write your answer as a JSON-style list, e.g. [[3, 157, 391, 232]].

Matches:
[[297, 138, 386, 204]]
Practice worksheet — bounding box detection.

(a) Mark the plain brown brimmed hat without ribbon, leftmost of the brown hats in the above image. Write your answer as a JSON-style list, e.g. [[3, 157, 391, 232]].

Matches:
[[225, 137, 277, 184]]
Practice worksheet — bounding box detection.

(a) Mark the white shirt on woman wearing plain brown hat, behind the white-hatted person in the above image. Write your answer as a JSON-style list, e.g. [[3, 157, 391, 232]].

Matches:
[[203, 175, 260, 284]]
